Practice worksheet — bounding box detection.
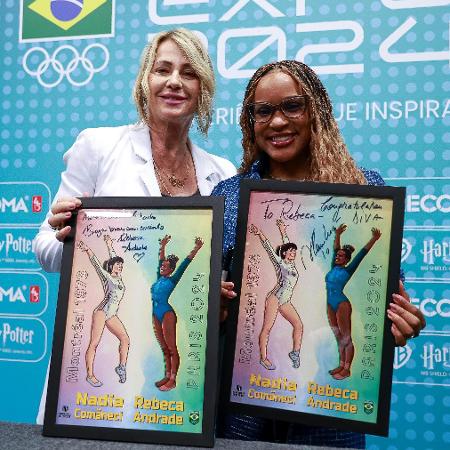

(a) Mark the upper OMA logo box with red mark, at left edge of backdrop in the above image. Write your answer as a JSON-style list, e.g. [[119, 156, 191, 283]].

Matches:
[[0, 181, 50, 227]]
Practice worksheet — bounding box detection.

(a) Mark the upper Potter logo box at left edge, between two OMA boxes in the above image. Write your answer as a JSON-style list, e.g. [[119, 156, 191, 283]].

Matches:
[[0, 228, 41, 270]]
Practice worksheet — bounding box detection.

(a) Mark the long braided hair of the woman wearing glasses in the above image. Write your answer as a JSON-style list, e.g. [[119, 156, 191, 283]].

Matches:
[[239, 60, 366, 184]]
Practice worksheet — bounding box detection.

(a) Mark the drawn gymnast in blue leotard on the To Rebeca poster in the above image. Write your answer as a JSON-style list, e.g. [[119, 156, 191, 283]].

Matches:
[[325, 224, 381, 380]]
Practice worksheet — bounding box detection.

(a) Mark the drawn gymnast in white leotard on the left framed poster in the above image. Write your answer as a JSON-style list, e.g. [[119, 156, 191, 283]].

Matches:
[[78, 235, 130, 387]]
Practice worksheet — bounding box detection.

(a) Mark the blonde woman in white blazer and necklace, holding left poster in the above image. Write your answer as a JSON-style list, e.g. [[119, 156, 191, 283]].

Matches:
[[35, 28, 236, 423]]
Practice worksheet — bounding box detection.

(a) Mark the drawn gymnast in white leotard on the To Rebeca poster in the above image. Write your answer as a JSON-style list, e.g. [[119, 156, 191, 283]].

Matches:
[[249, 219, 303, 370]]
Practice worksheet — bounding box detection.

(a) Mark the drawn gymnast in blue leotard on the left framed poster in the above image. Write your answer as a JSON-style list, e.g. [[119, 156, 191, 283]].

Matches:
[[151, 235, 203, 391]]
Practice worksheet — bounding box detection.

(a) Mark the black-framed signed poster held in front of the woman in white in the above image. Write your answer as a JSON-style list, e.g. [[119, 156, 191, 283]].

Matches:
[[44, 196, 223, 446]]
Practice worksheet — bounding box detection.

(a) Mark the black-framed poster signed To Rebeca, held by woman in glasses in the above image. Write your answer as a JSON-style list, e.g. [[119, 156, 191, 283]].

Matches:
[[223, 180, 405, 435]]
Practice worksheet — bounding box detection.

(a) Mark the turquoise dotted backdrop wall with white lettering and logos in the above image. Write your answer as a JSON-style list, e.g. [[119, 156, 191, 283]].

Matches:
[[0, 0, 450, 450]]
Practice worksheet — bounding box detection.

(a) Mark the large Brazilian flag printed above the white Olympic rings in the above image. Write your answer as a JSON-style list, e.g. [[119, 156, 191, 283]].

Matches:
[[19, 0, 114, 42]]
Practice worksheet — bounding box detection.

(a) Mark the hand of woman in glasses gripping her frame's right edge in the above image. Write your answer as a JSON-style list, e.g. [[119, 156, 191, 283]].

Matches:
[[387, 281, 426, 347]]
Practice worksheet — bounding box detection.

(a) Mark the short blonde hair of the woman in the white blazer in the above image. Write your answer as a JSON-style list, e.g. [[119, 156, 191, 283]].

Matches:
[[133, 28, 215, 136]]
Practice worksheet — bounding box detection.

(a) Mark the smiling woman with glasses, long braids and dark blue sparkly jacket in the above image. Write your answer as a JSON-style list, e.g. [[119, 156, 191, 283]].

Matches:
[[212, 60, 425, 448]]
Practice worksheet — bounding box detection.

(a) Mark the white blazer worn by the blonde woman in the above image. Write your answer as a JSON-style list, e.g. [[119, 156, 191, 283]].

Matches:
[[35, 121, 236, 272]]
